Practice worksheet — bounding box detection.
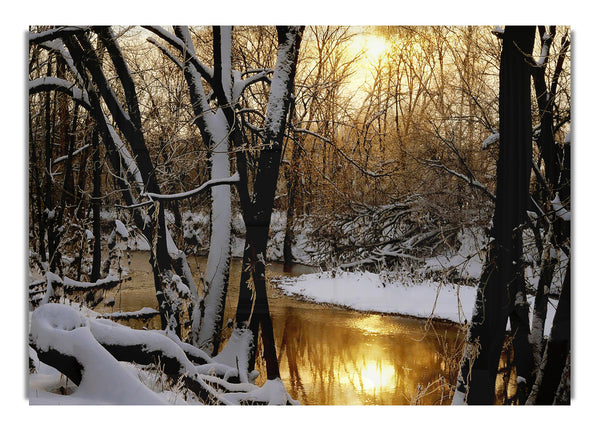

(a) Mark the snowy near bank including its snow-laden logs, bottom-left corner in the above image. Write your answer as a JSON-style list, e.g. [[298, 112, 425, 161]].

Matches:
[[28, 303, 298, 405]]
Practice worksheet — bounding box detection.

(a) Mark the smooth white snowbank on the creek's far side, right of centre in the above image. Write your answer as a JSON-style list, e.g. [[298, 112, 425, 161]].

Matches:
[[274, 269, 558, 335]]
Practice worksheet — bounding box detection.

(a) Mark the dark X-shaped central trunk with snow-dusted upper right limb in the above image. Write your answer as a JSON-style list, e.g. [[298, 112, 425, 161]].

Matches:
[[231, 27, 303, 380]]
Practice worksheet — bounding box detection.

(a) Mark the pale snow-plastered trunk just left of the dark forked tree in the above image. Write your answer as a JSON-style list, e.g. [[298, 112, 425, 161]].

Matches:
[[164, 27, 233, 355]]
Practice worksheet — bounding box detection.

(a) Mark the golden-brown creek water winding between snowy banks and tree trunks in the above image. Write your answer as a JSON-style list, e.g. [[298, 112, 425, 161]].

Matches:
[[96, 252, 460, 405]]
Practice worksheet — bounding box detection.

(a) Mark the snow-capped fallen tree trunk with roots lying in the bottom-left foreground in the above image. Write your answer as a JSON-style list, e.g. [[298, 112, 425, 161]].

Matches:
[[30, 303, 296, 405]]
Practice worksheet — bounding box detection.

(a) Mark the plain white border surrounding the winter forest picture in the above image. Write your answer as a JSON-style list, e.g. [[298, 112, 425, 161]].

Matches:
[[0, 0, 600, 430]]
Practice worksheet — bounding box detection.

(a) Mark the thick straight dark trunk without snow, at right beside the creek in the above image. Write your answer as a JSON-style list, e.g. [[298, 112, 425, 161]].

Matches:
[[457, 27, 535, 404]]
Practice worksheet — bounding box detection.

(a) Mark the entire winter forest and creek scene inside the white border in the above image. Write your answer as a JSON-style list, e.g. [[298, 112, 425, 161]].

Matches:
[[26, 25, 572, 405]]
